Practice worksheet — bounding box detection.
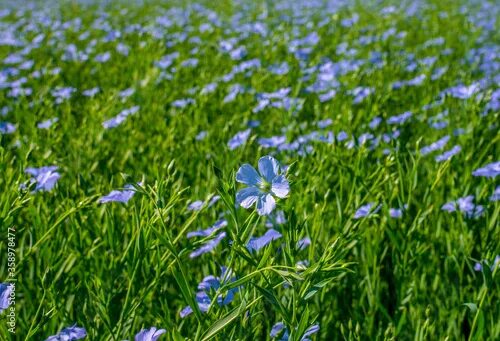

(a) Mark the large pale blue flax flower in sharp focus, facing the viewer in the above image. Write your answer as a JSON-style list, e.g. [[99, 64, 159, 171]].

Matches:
[[236, 156, 290, 215]]
